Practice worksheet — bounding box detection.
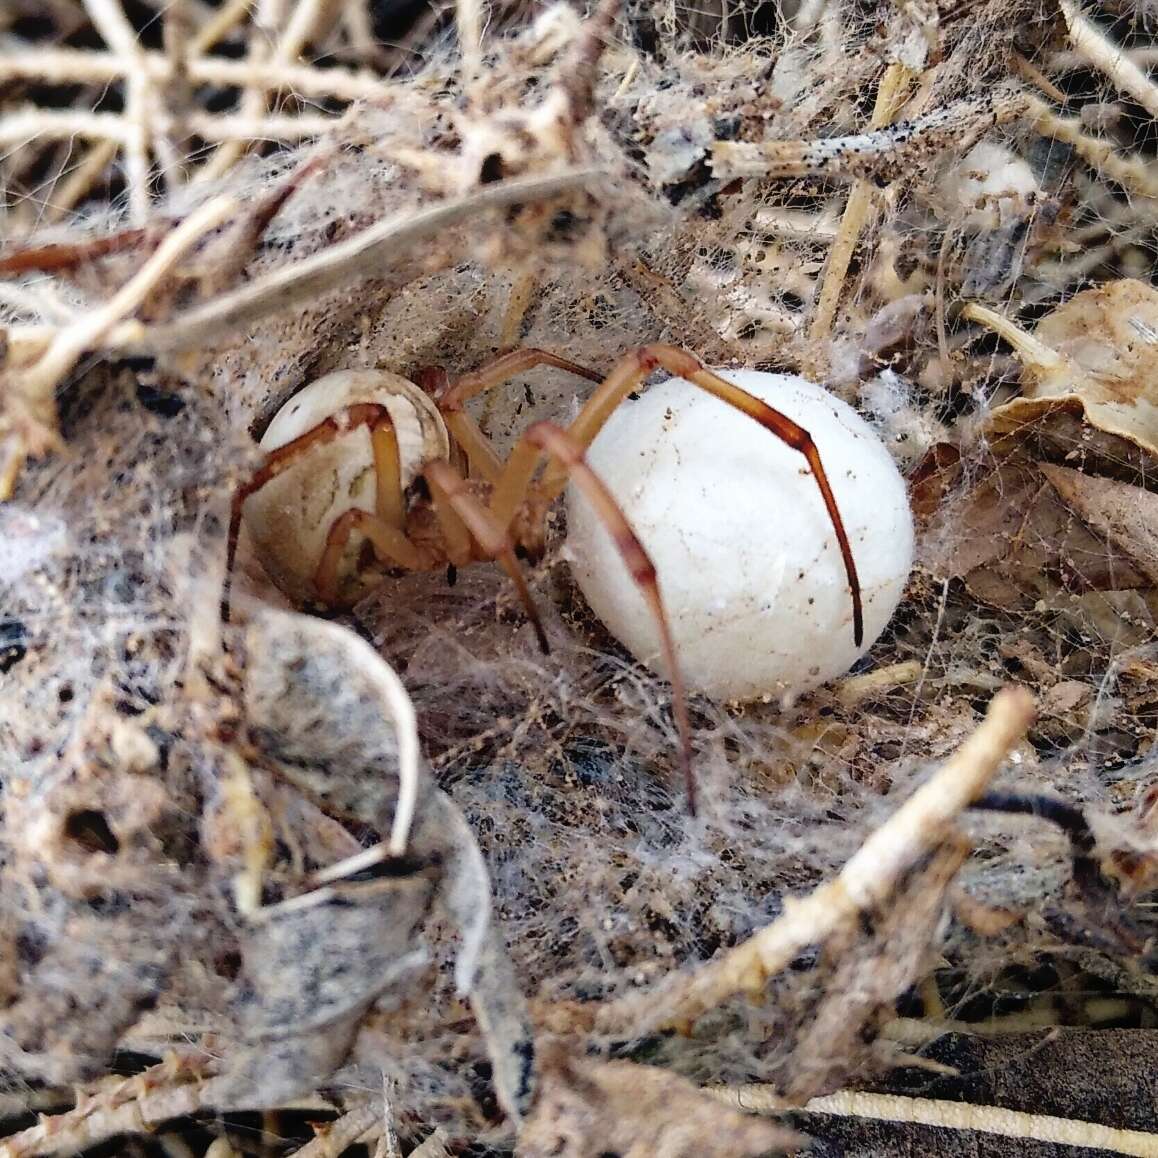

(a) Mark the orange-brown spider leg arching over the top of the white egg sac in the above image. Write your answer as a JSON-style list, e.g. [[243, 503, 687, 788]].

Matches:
[[532, 345, 864, 647]]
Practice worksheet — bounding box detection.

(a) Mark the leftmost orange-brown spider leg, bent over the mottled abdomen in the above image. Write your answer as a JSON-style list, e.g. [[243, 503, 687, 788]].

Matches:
[[221, 402, 405, 623]]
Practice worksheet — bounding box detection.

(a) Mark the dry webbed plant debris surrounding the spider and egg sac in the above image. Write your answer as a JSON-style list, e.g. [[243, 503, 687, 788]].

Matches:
[[0, 0, 1158, 1158]]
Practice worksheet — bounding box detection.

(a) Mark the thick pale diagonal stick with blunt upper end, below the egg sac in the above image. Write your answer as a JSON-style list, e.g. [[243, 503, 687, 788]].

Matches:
[[595, 688, 1034, 1032]]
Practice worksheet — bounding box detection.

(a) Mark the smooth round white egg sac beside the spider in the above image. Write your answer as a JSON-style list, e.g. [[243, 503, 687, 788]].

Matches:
[[567, 371, 913, 701]]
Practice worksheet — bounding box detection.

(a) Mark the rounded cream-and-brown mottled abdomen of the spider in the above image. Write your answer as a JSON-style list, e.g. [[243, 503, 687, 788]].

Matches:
[[242, 369, 449, 602]]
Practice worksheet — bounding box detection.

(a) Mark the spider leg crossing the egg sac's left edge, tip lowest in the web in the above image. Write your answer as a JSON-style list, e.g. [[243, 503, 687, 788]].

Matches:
[[492, 423, 696, 816]]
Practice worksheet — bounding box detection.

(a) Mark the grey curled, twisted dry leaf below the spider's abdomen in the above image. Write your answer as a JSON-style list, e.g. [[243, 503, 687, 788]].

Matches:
[[221, 610, 534, 1120]]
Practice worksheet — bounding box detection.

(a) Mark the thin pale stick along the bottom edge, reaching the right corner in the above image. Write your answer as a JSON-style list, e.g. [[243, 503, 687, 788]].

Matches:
[[711, 1085, 1158, 1158]]
